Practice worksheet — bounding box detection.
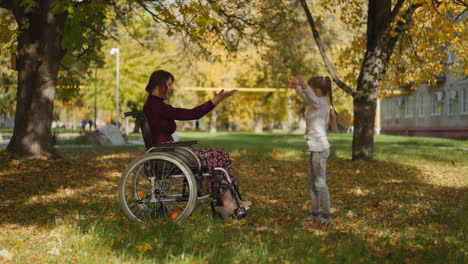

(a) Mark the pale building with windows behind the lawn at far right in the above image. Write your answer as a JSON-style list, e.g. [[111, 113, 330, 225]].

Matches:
[[380, 69, 468, 139]]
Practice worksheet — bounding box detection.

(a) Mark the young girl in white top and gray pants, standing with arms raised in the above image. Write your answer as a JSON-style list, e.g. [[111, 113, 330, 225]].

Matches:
[[288, 76, 336, 223]]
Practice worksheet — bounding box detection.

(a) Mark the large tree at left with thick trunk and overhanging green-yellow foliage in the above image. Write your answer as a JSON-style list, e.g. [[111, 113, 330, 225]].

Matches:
[[0, 0, 256, 158]]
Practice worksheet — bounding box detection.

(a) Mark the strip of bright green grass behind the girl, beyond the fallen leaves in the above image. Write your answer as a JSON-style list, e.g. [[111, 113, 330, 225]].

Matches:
[[176, 132, 468, 164]]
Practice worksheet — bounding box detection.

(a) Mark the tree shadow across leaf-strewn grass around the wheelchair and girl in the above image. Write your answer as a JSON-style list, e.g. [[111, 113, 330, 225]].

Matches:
[[0, 150, 467, 263]]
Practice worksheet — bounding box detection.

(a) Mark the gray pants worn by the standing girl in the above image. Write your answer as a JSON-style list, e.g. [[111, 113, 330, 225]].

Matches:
[[308, 148, 331, 215]]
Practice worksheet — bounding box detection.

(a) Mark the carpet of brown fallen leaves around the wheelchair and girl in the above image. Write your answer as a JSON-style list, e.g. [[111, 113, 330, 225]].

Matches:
[[0, 150, 467, 259]]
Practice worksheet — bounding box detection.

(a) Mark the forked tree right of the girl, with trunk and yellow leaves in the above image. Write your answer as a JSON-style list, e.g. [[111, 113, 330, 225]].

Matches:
[[300, 0, 467, 160]]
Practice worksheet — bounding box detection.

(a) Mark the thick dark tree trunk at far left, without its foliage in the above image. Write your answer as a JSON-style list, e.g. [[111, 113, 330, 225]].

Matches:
[[7, 0, 66, 158]]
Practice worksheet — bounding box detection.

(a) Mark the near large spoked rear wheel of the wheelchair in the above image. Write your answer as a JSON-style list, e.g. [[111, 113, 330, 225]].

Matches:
[[119, 152, 197, 222]]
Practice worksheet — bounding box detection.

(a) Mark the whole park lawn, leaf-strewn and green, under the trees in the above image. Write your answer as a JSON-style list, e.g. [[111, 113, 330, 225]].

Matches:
[[0, 132, 468, 263]]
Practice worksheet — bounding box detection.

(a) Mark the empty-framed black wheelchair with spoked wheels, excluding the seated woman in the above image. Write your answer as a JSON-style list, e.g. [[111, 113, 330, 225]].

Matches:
[[118, 111, 247, 222]]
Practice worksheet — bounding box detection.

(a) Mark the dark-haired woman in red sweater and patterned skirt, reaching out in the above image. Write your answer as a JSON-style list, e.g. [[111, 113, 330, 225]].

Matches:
[[120, 70, 251, 222]]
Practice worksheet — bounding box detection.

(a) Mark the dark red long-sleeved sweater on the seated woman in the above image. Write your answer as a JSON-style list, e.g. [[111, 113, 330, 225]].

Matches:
[[143, 95, 214, 144]]
